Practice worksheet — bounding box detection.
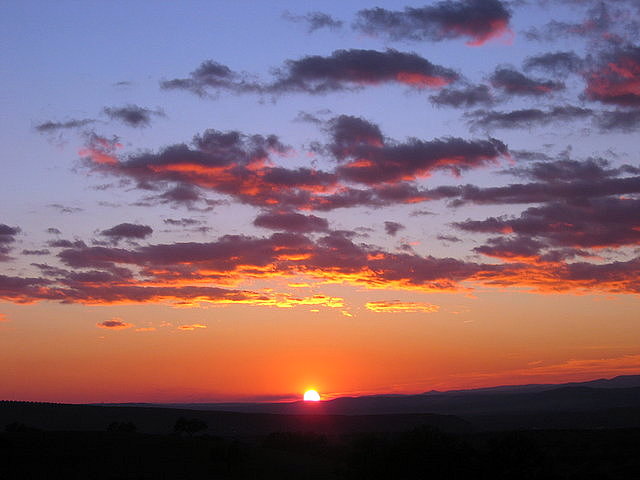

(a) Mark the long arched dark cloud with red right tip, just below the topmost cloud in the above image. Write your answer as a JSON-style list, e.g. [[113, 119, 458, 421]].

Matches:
[[269, 49, 458, 94]]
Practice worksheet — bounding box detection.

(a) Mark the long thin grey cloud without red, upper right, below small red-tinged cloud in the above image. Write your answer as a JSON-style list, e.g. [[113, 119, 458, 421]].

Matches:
[[466, 105, 594, 129]]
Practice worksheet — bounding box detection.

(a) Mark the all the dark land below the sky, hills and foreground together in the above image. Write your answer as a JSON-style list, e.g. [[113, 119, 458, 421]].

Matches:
[[0, 376, 640, 480]]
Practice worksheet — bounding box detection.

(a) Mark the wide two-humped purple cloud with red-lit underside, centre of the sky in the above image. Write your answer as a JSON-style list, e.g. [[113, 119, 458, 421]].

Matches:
[[83, 119, 508, 211]]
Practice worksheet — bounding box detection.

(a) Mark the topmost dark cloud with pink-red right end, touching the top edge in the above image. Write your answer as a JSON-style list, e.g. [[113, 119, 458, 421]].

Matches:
[[354, 0, 511, 46]]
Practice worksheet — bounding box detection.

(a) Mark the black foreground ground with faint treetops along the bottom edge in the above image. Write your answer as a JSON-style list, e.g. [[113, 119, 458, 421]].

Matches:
[[0, 426, 640, 480]]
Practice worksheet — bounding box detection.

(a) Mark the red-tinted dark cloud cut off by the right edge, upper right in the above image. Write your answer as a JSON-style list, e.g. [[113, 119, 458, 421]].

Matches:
[[585, 46, 640, 107]]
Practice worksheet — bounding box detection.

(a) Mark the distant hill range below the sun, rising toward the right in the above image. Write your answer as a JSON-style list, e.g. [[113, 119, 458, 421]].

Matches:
[[124, 375, 640, 415]]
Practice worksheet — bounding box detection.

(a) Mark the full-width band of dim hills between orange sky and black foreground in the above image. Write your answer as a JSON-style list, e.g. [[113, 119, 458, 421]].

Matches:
[[5, 375, 640, 436]]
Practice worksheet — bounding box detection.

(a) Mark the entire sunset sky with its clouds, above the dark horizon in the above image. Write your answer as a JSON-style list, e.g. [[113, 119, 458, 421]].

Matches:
[[0, 0, 640, 403]]
